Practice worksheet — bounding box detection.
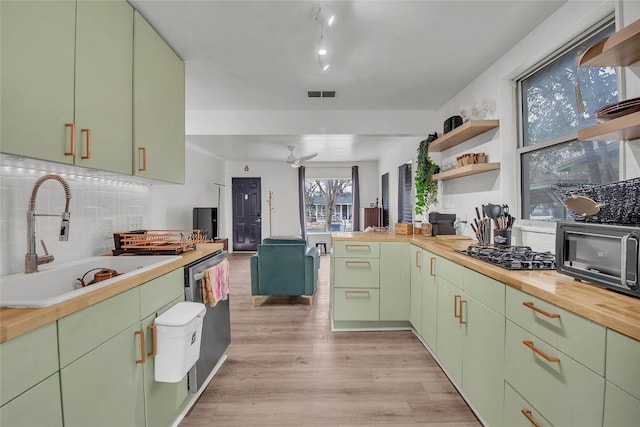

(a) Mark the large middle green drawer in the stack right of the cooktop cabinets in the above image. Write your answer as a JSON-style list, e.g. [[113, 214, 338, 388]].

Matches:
[[505, 321, 605, 427]]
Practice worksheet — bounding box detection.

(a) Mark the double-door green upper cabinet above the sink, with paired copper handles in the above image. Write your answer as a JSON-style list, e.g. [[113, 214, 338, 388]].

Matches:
[[1, 1, 133, 174]]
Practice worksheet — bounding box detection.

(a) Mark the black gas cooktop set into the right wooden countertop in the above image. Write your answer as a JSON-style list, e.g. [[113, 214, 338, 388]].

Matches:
[[456, 245, 556, 270]]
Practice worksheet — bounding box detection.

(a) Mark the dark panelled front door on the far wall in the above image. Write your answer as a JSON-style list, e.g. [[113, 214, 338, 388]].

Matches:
[[231, 178, 262, 251]]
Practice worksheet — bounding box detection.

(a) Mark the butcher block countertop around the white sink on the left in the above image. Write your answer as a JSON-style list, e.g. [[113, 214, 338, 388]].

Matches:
[[0, 243, 222, 343]]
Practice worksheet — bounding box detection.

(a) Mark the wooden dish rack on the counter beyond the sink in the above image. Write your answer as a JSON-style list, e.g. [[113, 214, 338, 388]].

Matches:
[[112, 230, 206, 255]]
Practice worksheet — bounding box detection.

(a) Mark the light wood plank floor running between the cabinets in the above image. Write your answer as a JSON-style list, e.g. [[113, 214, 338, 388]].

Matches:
[[181, 254, 480, 427]]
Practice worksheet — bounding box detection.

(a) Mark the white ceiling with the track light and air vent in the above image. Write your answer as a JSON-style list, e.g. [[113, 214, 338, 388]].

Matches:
[[129, 0, 564, 161]]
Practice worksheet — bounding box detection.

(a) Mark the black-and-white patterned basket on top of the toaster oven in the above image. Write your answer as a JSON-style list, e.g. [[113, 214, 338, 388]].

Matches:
[[549, 178, 640, 224]]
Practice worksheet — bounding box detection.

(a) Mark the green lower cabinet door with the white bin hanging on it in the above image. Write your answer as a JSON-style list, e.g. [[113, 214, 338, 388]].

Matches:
[[141, 298, 188, 427]]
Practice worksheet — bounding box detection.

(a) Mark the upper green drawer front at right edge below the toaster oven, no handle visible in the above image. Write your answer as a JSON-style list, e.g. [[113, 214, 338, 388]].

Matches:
[[605, 329, 640, 400]]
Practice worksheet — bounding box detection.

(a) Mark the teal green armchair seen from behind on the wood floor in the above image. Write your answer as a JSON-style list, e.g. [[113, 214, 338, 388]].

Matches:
[[251, 237, 320, 307]]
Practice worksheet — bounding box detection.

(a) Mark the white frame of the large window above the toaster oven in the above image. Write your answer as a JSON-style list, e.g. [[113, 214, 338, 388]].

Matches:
[[513, 11, 625, 224]]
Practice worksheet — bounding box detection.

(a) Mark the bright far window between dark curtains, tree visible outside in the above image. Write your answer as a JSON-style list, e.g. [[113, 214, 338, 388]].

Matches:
[[304, 178, 353, 233]]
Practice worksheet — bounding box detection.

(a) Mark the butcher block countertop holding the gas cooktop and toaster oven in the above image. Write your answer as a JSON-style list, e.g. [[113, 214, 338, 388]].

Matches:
[[331, 232, 640, 340]]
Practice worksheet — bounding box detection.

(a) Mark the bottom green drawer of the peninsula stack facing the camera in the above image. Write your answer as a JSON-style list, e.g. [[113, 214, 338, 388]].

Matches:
[[333, 288, 380, 320]]
